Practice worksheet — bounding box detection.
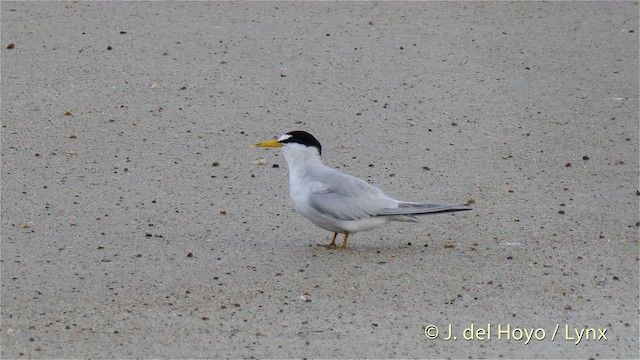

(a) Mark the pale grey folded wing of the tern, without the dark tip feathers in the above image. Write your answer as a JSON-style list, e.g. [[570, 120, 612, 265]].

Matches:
[[309, 169, 398, 220]]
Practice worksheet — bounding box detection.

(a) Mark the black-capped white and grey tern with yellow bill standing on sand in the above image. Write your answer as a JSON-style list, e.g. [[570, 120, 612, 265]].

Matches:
[[252, 130, 472, 249]]
